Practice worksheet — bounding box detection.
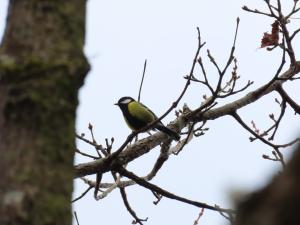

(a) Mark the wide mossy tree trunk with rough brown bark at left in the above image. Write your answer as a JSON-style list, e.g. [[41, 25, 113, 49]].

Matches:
[[0, 0, 89, 225]]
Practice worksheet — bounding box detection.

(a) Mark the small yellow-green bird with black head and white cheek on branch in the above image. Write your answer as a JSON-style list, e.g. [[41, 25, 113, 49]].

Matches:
[[115, 97, 180, 141]]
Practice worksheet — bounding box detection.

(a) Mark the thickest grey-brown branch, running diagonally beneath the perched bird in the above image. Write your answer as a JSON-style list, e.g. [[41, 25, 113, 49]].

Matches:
[[75, 62, 300, 177]]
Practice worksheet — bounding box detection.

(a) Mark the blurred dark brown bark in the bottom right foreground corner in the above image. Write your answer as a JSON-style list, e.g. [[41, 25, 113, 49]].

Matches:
[[235, 146, 300, 225]]
